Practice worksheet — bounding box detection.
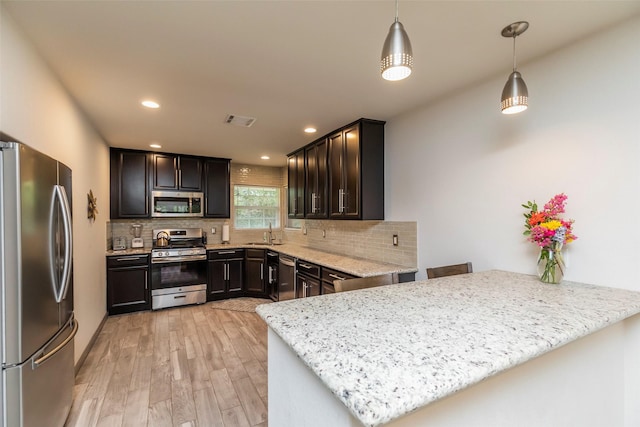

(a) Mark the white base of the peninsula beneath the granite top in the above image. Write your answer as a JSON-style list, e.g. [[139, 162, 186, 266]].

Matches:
[[268, 315, 640, 427]]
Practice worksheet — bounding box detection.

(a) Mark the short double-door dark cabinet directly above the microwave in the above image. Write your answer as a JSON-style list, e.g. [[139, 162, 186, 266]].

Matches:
[[153, 154, 202, 191]]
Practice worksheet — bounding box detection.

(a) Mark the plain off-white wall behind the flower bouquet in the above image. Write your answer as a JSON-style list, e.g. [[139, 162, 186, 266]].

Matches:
[[385, 17, 640, 291]]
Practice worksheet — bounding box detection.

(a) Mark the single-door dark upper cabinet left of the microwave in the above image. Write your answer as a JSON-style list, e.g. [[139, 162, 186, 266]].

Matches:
[[110, 148, 151, 219]]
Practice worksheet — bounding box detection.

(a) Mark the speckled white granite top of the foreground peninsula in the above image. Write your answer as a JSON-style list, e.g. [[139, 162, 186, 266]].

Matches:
[[257, 271, 640, 426]]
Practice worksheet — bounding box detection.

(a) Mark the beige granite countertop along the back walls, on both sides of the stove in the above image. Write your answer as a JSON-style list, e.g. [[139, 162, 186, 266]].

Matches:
[[107, 243, 418, 277]]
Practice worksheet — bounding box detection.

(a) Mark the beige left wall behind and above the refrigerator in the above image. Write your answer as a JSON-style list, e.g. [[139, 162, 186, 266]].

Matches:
[[0, 10, 109, 361]]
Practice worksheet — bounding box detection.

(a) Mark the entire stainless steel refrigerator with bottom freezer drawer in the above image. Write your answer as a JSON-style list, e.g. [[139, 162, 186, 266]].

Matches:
[[0, 134, 78, 427]]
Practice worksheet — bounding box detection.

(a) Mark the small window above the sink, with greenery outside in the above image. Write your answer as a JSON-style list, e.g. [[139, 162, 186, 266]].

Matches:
[[233, 185, 280, 229]]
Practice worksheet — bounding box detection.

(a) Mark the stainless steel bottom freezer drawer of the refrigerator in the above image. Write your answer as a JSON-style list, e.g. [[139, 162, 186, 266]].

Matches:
[[2, 320, 77, 427]]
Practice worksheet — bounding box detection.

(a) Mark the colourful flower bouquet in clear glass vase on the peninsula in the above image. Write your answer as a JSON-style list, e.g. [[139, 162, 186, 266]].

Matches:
[[522, 193, 577, 283]]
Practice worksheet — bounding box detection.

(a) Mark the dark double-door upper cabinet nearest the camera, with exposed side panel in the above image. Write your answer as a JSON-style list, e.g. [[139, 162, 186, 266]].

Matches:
[[327, 119, 384, 220]]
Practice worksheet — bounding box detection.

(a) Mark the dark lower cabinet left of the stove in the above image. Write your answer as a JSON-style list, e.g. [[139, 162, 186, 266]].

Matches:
[[107, 255, 151, 314]]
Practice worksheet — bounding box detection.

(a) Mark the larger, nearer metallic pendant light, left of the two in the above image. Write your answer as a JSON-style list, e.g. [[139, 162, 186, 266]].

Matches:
[[380, 0, 413, 81]]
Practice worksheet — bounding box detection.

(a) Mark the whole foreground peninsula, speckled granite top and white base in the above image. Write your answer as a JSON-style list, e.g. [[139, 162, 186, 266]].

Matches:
[[257, 271, 640, 427]]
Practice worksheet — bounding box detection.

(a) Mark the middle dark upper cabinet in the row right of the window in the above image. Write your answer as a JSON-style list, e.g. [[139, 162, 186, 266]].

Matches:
[[304, 138, 329, 219]]
